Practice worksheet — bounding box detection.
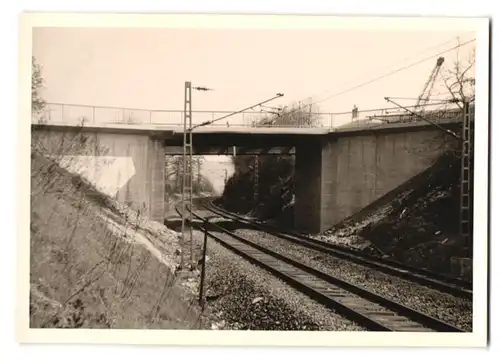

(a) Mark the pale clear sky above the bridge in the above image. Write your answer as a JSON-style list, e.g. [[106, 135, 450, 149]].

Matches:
[[33, 28, 475, 125]]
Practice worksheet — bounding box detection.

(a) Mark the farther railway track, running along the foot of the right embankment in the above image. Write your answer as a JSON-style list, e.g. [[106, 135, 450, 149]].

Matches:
[[202, 202, 472, 300]]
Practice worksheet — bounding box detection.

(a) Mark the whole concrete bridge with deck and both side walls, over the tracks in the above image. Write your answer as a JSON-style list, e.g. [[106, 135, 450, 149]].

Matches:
[[32, 103, 461, 233]]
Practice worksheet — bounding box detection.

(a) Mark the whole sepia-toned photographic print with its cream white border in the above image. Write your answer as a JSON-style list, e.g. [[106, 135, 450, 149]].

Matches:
[[18, 13, 490, 346]]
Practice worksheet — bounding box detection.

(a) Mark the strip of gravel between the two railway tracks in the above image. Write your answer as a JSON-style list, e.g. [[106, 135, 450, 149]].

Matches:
[[229, 229, 472, 331]]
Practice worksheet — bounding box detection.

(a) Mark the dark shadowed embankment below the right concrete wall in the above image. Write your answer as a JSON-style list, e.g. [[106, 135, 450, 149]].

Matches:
[[321, 150, 467, 273]]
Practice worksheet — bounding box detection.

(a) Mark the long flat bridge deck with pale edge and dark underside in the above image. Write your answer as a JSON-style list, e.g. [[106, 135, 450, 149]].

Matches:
[[32, 116, 459, 155]]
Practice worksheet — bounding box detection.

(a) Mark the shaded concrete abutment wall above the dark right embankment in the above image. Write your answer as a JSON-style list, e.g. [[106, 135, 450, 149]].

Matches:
[[295, 128, 455, 233]]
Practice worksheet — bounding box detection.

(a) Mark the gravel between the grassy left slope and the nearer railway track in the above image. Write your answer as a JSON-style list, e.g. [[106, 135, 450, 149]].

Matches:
[[184, 212, 365, 331]]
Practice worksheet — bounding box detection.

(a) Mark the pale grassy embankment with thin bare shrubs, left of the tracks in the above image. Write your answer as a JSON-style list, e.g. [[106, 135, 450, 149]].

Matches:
[[30, 152, 200, 329]]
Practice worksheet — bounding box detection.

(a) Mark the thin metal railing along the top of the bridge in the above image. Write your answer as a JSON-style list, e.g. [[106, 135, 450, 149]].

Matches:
[[32, 103, 461, 129]]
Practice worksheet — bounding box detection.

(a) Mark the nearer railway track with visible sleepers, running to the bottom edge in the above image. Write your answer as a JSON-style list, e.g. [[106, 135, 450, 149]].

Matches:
[[176, 201, 463, 332]]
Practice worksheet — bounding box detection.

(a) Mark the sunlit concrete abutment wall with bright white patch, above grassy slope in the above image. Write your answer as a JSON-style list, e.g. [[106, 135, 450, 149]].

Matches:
[[32, 130, 165, 222]]
